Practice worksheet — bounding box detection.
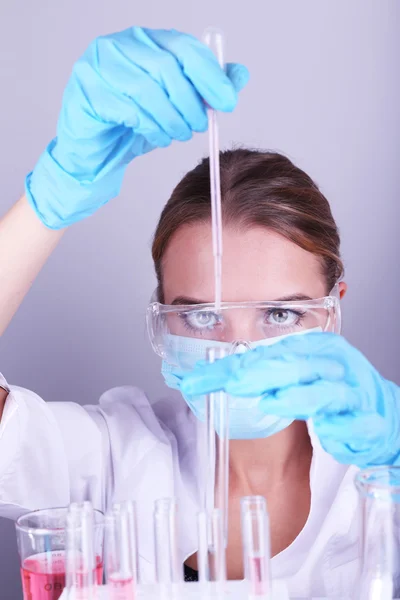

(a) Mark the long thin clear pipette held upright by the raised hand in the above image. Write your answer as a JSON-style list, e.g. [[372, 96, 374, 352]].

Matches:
[[203, 27, 225, 310]]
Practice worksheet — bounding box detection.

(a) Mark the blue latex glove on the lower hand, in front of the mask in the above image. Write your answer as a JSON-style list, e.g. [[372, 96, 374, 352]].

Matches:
[[181, 333, 400, 468]]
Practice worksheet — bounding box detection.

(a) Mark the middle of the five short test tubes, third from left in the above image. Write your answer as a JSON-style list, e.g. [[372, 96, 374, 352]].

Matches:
[[154, 498, 183, 585]]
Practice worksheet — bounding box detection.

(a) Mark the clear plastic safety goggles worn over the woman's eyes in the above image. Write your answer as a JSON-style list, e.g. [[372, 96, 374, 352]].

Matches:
[[147, 284, 341, 368]]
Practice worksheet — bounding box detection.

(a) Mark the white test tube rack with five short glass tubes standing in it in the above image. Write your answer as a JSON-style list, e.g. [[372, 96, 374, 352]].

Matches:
[[62, 496, 282, 600]]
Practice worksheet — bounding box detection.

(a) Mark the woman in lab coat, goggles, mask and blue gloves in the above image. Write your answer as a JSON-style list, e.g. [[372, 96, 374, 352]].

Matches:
[[0, 28, 400, 597]]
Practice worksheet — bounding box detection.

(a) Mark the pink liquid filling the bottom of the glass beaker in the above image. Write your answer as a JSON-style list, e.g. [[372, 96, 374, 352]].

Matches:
[[21, 552, 103, 600]]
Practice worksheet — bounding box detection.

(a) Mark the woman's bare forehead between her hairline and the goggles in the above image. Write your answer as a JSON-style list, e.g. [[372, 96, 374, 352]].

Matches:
[[163, 223, 326, 304]]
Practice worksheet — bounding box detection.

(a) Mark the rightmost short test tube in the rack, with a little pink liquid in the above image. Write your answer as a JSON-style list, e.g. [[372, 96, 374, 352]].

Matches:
[[241, 496, 271, 597]]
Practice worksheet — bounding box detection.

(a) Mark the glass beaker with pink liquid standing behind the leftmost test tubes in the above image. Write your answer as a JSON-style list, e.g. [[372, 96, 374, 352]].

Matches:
[[16, 507, 104, 600]]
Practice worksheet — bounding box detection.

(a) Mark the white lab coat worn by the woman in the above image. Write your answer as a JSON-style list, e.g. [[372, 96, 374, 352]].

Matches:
[[0, 376, 359, 598]]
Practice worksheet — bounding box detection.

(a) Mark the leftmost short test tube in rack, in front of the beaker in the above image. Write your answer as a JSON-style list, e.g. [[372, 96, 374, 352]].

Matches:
[[66, 502, 97, 600]]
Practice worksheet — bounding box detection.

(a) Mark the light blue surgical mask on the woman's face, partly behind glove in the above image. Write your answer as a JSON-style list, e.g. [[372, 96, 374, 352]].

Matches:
[[161, 327, 321, 440]]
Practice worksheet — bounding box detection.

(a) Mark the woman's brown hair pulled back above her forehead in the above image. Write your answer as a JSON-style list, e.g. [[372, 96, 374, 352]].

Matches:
[[152, 148, 344, 302]]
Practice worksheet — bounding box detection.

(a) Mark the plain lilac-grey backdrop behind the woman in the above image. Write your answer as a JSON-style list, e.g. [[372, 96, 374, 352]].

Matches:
[[0, 0, 400, 599]]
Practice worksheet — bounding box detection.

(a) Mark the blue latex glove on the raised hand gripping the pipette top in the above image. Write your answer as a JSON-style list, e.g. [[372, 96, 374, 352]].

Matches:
[[26, 27, 248, 229]]
